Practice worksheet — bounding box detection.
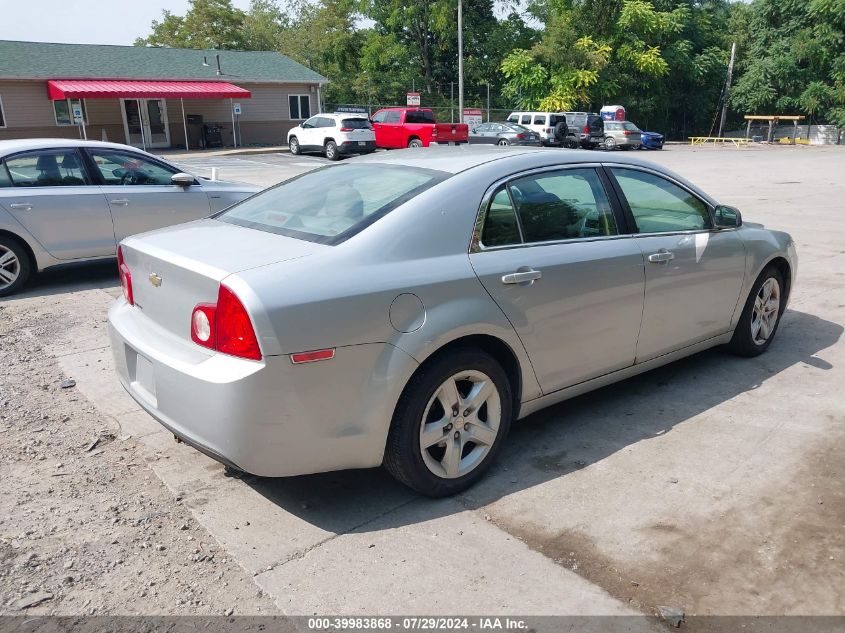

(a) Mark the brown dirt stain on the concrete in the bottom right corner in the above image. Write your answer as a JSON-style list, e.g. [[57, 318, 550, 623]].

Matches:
[[497, 433, 845, 630]]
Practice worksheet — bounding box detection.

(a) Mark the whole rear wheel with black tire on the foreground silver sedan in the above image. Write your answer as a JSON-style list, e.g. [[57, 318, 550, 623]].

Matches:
[[384, 348, 513, 497]]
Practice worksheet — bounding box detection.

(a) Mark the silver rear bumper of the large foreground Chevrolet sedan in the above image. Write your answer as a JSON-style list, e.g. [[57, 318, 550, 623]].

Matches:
[[109, 299, 417, 477]]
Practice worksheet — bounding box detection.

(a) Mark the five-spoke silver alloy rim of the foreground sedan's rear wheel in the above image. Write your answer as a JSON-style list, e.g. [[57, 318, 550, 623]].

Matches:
[[420, 370, 502, 479]]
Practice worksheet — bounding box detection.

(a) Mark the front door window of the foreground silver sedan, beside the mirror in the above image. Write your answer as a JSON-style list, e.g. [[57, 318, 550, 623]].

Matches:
[[611, 167, 711, 233]]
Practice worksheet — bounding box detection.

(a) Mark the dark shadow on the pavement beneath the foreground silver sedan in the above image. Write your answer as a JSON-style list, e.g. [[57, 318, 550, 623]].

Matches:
[[243, 310, 844, 533]]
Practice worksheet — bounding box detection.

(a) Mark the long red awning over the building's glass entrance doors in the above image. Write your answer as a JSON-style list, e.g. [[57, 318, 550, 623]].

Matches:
[[47, 79, 252, 101]]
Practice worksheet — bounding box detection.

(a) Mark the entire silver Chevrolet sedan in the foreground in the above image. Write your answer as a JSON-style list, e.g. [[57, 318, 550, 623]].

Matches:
[[109, 147, 797, 496]]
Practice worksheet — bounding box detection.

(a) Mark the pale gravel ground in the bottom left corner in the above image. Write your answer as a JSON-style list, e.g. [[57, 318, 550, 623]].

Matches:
[[0, 302, 277, 615]]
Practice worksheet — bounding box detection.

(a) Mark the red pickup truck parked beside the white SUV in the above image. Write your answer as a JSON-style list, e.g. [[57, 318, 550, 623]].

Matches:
[[371, 108, 469, 149]]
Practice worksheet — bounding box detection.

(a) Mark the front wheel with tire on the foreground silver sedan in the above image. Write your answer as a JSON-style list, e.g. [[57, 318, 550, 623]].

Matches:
[[728, 266, 786, 357]]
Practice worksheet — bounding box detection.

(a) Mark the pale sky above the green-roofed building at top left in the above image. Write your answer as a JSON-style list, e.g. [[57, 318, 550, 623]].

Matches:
[[0, 0, 249, 45]]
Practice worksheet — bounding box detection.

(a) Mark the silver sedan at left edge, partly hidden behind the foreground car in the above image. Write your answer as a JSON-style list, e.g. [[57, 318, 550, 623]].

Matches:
[[0, 139, 260, 297]]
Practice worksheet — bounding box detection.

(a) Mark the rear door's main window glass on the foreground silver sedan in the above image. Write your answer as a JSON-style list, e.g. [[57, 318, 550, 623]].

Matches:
[[509, 169, 619, 242]]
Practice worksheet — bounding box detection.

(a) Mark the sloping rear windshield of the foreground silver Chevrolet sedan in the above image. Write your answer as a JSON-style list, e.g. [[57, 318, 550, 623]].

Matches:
[[215, 163, 449, 245]]
